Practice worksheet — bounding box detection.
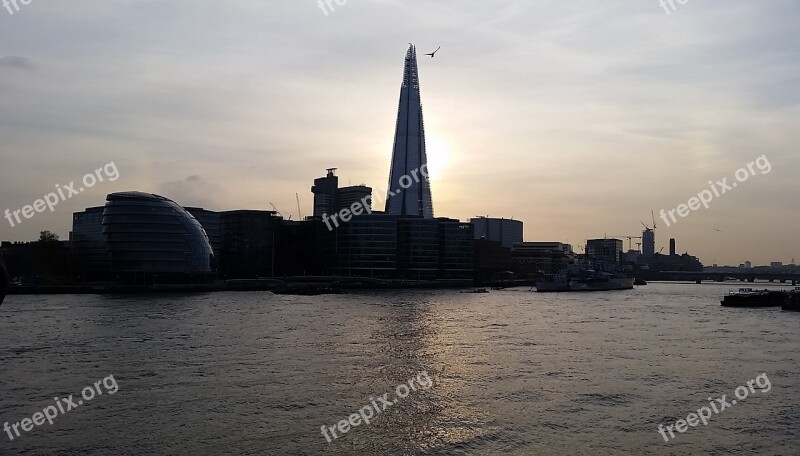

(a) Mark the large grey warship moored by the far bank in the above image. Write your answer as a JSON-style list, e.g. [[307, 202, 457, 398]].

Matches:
[[535, 261, 634, 293]]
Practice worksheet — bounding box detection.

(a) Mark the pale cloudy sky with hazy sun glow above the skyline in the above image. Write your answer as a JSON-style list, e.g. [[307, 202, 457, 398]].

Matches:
[[0, 0, 800, 265]]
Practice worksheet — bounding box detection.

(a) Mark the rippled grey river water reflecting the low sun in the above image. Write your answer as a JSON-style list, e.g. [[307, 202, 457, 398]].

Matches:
[[0, 284, 800, 455]]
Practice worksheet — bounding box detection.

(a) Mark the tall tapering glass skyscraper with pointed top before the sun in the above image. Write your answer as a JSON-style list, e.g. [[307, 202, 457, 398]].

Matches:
[[386, 45, 433, 218]]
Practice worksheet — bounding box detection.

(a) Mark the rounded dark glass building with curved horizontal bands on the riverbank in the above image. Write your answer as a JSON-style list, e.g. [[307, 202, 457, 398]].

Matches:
[[103, 192, 214, 284]]
